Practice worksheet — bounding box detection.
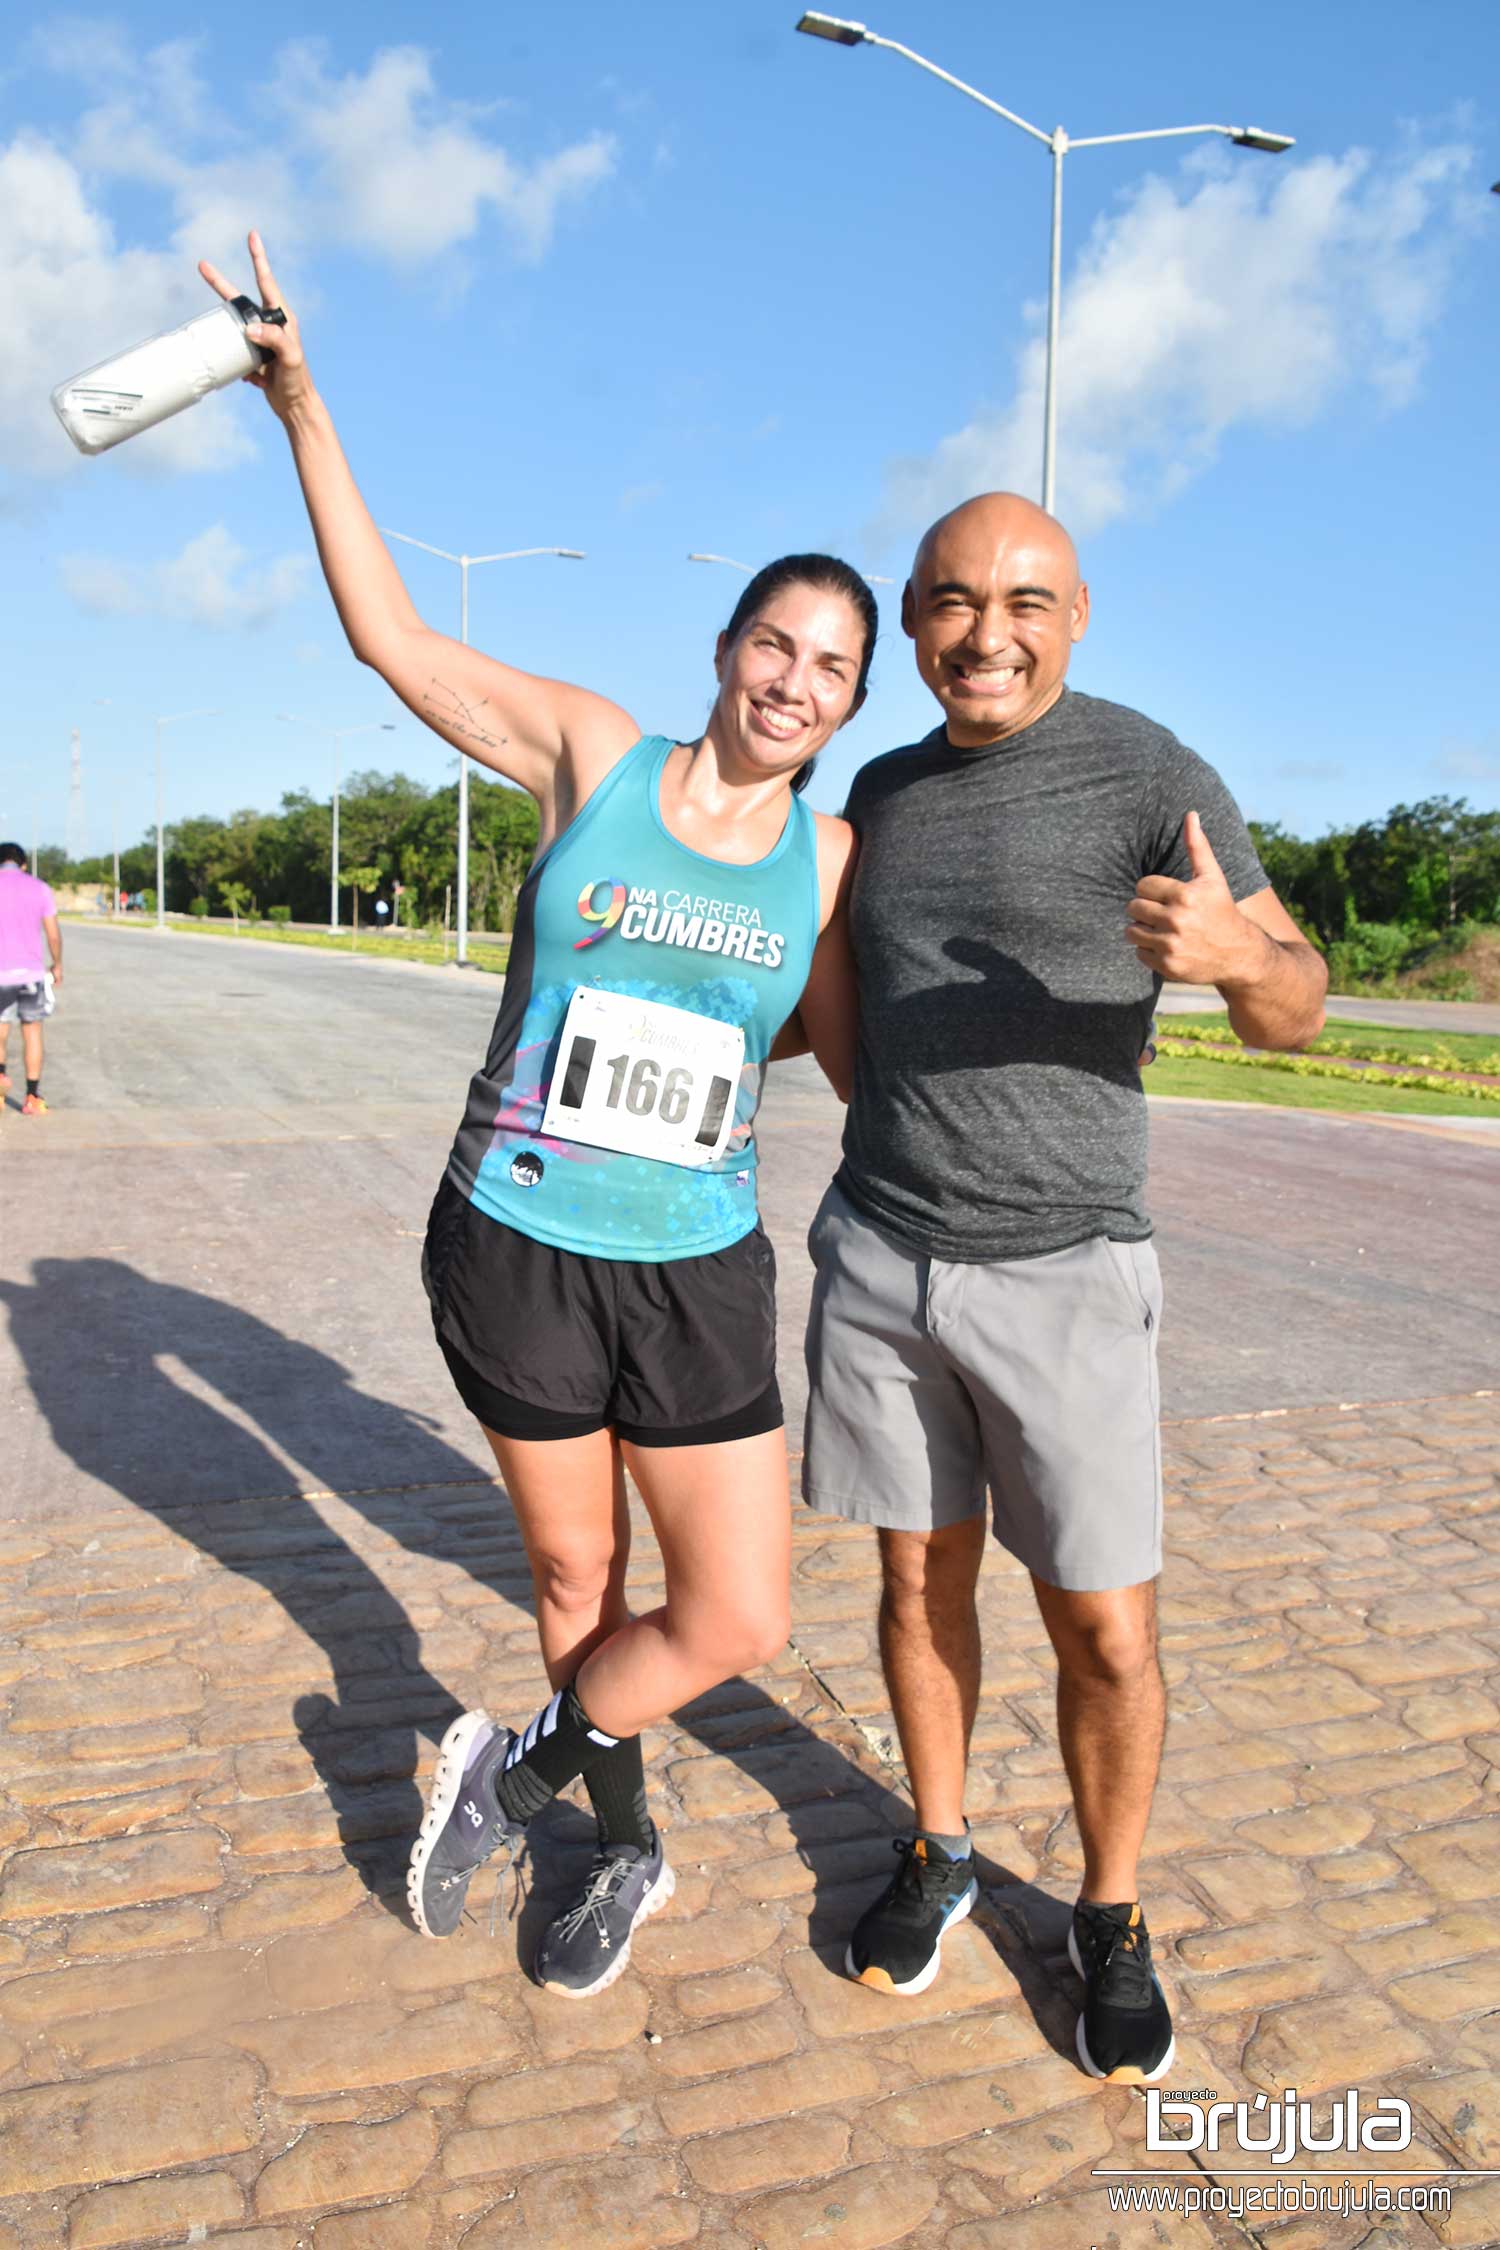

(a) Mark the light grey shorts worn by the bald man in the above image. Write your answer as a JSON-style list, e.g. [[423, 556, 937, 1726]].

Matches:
[[803, 1188, 1160, 1593]]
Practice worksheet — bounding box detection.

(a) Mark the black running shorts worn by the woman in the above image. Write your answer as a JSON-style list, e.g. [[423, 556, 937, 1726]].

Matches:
[[423, 1177, 783, 1445]]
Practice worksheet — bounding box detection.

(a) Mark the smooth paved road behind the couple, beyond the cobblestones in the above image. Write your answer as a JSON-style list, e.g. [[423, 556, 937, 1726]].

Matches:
[[0, 927, 1500, 1517]]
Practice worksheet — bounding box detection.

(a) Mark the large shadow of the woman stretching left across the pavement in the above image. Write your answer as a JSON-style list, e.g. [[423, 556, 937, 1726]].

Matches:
[[0, 1258, 477, 1904]]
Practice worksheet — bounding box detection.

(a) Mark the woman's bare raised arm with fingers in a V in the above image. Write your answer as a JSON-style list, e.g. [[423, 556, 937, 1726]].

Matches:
[[198, 234, 639, 812]]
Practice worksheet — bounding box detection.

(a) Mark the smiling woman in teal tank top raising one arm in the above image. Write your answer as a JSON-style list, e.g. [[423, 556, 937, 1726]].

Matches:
[[200, 234, 877, 1998]]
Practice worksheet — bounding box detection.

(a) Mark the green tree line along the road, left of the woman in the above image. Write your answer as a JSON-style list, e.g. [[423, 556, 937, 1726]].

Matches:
[[36, 772, 537, 929]]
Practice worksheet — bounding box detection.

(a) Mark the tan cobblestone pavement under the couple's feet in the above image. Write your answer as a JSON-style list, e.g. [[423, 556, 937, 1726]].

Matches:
[[0, 1395, 1500, 2250]]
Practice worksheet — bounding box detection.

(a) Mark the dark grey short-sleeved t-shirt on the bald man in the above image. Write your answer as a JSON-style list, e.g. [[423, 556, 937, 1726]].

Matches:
[[839, 691, 1266, 1262]]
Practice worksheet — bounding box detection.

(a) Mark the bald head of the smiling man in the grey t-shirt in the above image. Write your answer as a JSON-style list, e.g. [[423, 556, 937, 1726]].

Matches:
[[902, 493, 1088, 749]]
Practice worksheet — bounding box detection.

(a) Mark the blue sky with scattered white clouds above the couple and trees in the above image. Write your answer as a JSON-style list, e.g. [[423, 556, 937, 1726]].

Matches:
[[0, 0, 1500, 851]]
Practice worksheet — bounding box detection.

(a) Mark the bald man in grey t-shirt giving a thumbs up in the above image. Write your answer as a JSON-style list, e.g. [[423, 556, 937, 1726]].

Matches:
[[805, 493, 1327, 2081]]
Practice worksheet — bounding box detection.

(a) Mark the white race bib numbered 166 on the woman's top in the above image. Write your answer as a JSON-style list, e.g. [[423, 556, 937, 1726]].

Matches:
[[542, 986, 744, 1166]]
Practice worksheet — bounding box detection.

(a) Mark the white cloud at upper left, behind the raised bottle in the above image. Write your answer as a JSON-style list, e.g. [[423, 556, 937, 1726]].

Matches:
[[0, 18, 614, 477]]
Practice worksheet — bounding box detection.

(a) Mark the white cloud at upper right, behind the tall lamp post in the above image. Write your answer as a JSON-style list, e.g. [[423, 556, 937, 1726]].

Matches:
[[877, 142, 1480, 538]]
